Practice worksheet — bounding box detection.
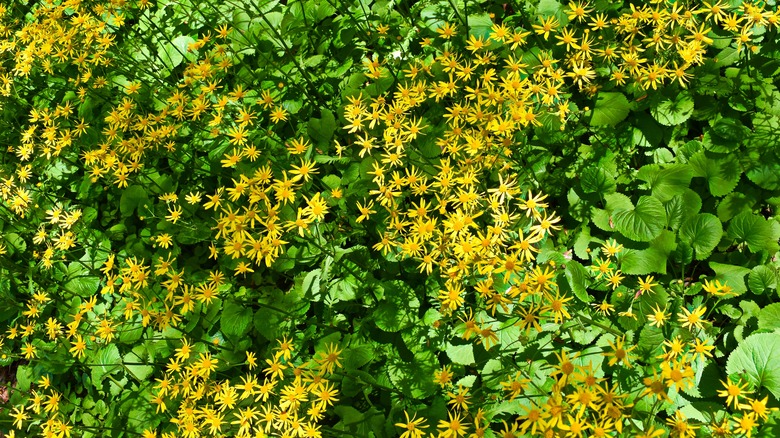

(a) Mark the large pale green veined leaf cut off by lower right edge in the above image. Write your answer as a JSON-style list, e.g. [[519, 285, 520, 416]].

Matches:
[[726, 333, 780, 399]]
